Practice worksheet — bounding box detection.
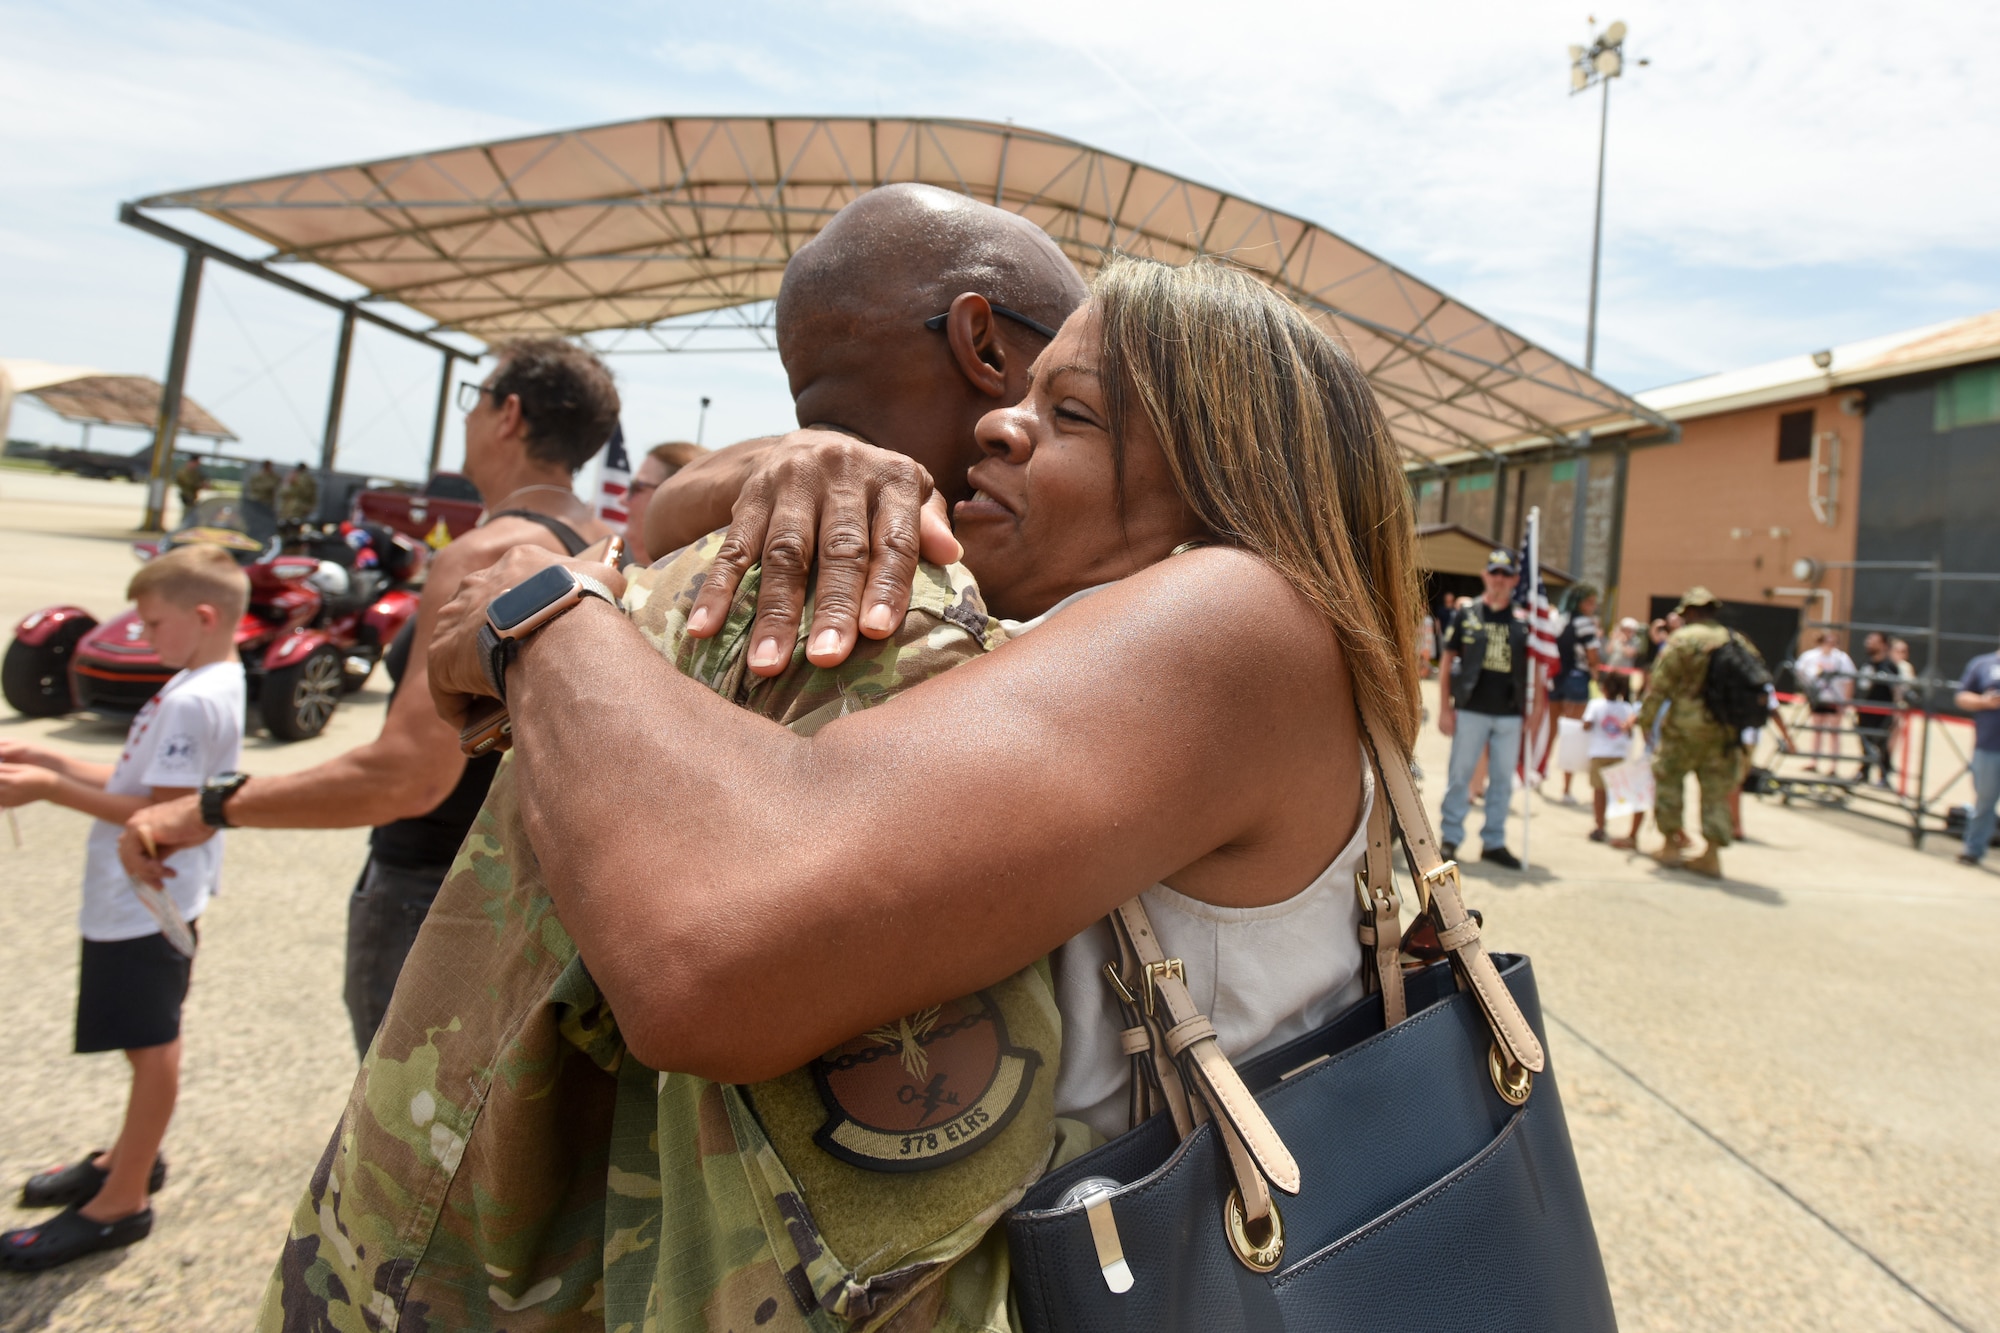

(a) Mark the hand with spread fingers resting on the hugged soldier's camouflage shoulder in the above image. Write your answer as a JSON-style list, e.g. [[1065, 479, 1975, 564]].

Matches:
[[688, 428, 960, 677]]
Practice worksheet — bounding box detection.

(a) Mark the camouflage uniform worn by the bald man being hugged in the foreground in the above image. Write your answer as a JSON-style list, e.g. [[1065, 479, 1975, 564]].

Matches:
[[260, 536, 1088, 1331]]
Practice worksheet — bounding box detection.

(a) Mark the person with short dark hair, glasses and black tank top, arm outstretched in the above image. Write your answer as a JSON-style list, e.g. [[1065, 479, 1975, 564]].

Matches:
[[120, 338, 618, 1055]]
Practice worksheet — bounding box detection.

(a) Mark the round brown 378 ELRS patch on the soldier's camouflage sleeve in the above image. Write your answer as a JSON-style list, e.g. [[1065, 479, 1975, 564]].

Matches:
[[812, 991, 1042, 1171]]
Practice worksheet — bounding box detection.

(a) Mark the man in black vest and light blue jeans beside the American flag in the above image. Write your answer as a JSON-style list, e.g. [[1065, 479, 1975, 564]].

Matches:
[[1438, 550, 1528, 871]]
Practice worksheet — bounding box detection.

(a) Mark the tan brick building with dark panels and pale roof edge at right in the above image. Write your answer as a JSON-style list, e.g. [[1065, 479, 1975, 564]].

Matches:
[[1412, 310, 2000, 673]]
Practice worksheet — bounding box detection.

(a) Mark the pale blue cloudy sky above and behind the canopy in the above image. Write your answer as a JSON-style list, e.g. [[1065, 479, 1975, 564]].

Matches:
[[0, 0, 2000, 476]]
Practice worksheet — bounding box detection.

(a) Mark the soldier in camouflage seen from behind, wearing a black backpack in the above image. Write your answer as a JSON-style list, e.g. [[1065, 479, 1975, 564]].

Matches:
[[1638, 588, 1754, 879]]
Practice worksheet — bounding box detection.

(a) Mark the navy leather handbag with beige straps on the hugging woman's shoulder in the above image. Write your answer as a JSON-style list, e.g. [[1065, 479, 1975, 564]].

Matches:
[[1008, 700, 1616, 1333]]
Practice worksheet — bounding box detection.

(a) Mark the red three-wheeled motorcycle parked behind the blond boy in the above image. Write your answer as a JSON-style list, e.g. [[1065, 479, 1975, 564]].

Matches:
[[0, 496, 430, 741]]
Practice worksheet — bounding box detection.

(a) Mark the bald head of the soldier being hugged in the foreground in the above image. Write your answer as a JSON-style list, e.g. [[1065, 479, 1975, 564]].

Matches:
[[778, 184, 1088, 500]]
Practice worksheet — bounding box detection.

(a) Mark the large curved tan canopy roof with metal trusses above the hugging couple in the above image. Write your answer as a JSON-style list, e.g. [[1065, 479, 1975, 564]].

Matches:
[[138, 116, 1666, 460]]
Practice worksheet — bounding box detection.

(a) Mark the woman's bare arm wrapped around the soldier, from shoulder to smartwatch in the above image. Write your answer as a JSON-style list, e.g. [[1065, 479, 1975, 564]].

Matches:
[[482, 550, 1360, 1081]]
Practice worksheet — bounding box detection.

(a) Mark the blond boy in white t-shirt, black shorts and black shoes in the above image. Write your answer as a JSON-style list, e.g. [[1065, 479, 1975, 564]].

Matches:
[[0, 546, 250, 1269]]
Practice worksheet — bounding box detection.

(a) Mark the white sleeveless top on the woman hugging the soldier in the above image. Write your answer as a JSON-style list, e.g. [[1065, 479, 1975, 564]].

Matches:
[[1002, 584, 1374, 1139]]
